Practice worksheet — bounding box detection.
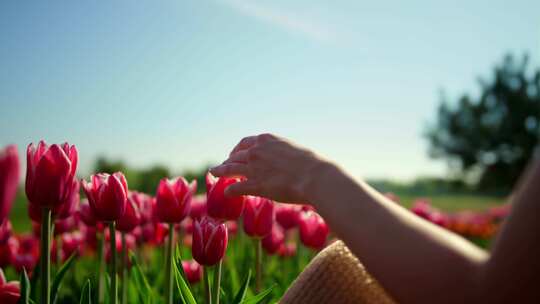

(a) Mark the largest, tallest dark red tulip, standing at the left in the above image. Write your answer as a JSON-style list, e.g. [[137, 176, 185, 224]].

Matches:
[[26, 141, 78, 208]]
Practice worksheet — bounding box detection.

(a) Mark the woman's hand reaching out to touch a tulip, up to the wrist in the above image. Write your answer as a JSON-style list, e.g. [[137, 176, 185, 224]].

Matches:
[[210, 134, 328, 203]]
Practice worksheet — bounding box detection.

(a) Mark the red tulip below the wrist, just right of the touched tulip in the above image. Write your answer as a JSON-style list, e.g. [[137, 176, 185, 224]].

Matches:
[[244, 196, 275, 237]]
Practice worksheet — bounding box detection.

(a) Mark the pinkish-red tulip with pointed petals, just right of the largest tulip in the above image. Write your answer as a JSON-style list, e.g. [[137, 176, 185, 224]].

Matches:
[[83, 172, 128, 222]]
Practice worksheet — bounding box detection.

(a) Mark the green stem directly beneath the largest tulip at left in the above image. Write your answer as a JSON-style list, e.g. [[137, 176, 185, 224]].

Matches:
[[40, 207, 52, 304]]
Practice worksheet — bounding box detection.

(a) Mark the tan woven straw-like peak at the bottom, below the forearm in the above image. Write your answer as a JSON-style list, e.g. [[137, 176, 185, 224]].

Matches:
[[280, 241, 395, 304]]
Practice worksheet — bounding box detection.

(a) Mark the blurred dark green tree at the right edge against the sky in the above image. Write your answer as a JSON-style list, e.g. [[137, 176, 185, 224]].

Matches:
[[427, 55, 540, 190]]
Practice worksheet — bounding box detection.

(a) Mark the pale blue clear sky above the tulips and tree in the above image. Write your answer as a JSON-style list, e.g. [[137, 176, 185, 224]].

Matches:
[[0, 0, 540, 179]]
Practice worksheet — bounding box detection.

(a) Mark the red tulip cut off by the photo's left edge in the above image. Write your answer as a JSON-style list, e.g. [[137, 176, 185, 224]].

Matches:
[[0, 145, 19, 224]]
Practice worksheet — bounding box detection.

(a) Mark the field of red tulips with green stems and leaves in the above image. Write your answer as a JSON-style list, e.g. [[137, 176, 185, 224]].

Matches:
[[0, 141, 510, 304]]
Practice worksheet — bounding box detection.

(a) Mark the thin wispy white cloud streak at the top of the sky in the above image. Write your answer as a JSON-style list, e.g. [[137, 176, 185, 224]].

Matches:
[[222, 0, 335, 42]]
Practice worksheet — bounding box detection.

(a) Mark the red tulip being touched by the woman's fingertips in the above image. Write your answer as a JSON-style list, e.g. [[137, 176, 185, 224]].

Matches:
[[206, 173, 244, 220]]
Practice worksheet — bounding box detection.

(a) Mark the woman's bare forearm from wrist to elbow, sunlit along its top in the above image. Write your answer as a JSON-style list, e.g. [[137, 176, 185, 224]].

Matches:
[[305, 163, 487, 303]]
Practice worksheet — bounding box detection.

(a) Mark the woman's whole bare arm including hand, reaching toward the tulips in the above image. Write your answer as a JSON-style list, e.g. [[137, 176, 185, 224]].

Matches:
[[212, 135, 540, 303]]
